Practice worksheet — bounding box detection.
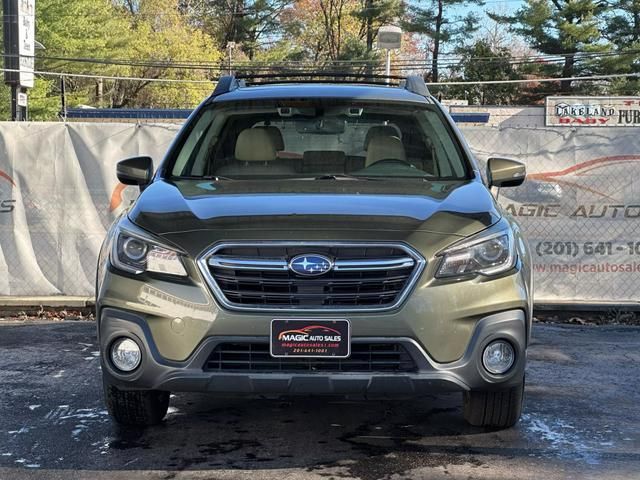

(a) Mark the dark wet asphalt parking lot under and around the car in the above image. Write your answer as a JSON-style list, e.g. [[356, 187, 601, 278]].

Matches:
[[0, 320, 640, 480]]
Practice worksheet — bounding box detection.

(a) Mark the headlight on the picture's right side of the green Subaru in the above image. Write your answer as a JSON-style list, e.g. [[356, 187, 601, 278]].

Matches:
[[436, 230, 516, 278]]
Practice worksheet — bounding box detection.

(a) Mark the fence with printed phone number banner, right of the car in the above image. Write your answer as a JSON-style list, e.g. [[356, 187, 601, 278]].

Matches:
[[453, 107, 640, 303]]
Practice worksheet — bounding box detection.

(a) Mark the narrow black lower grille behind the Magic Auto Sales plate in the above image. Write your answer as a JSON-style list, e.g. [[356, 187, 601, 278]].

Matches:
[[204, 343, 417, 373]]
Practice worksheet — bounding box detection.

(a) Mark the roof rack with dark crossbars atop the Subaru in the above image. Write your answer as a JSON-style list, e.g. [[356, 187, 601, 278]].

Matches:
[[212, 72, 430, 97]]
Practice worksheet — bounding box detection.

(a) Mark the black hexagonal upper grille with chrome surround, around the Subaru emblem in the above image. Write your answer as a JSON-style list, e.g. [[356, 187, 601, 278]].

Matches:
[[201, 243, 423, 310]]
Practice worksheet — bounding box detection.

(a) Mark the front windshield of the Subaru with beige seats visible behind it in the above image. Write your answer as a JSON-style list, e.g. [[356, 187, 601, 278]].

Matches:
[[171, 100, 467, 180]]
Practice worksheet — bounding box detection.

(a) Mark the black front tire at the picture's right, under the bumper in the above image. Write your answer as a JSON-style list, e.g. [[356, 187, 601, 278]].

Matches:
[[463, 378, 524, 428]]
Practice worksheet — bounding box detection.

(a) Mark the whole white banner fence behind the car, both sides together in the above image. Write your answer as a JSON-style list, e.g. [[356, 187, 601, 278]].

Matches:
[[0, 119, 640, 303]]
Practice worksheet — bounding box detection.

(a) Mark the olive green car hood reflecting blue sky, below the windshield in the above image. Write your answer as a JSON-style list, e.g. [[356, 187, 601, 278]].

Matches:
[[129, 179, 500, 240]]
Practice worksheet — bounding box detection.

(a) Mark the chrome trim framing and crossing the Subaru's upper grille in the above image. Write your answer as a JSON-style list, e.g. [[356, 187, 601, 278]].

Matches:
[[197, 241, 426, 313]]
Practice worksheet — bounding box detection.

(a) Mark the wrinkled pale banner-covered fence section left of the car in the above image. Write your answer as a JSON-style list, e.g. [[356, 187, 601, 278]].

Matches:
[[0, 122, 180, 296]]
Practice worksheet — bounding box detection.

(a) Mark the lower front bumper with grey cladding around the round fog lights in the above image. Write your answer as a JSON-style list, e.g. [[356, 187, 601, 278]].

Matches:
[[99, 308, 527, 397]]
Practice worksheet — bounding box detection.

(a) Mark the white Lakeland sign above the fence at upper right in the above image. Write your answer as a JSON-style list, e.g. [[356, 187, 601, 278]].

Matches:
[[545, 97, 640, 127]]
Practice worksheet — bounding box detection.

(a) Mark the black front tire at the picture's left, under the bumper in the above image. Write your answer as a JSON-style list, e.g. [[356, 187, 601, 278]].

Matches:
[[104, 382, 169, 427]]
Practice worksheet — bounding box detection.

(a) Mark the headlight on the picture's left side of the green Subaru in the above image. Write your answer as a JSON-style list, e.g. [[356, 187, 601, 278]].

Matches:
[[111, 230, 187, 277]]
